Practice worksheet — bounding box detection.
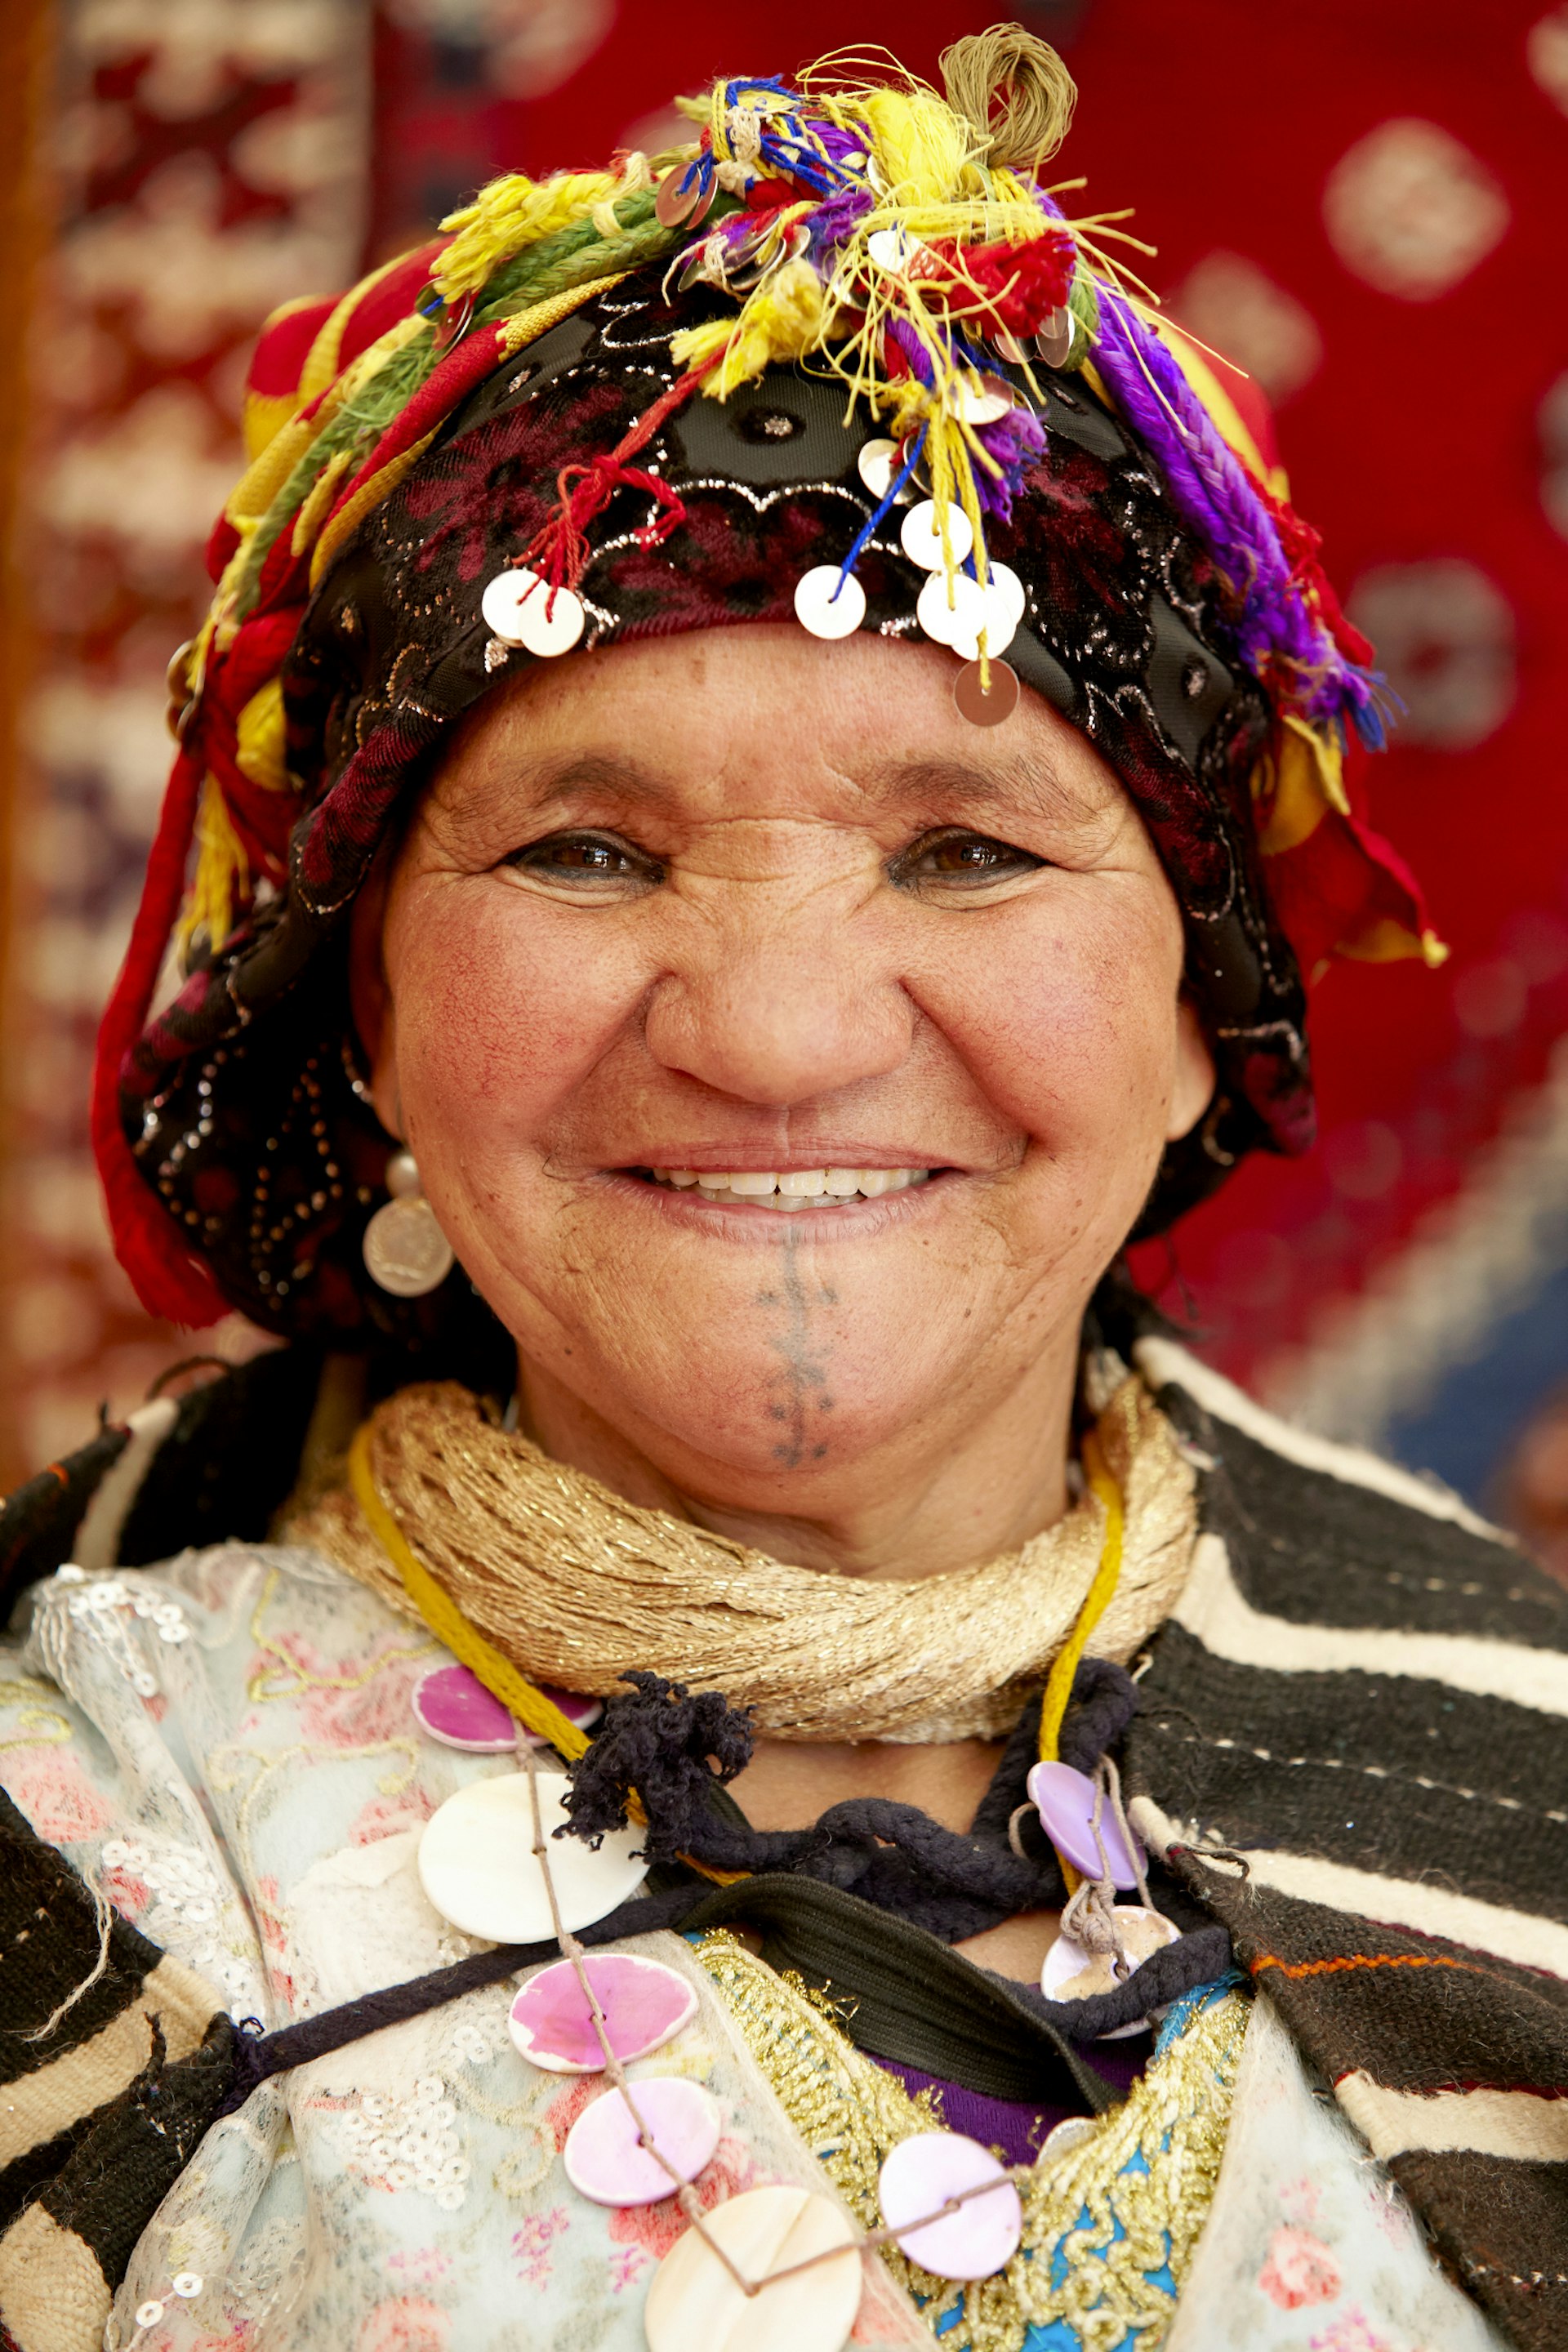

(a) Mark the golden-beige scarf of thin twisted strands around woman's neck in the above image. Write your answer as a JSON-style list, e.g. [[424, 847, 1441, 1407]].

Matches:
[[282, 1379, 1196, 1743]]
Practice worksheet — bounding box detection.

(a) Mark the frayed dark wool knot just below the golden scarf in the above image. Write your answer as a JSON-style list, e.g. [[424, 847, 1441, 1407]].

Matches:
[[557, 1673, 752, 1863]]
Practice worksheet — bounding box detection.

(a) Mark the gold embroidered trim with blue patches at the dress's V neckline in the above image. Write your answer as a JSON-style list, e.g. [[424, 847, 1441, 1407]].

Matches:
[[696, 1929, 1249, 2352]]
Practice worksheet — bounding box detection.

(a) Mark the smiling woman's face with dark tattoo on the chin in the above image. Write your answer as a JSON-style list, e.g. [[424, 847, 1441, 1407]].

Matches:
[[358, 628, 1213, 1508]]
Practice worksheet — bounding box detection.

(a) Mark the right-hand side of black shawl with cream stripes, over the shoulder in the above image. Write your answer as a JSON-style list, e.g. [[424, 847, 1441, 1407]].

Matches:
[[1124, 1341, 1568, 2352]]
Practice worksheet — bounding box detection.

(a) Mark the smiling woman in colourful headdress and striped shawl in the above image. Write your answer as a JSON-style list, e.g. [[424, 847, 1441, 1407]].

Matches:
[[0, 30, 1568, 2352]]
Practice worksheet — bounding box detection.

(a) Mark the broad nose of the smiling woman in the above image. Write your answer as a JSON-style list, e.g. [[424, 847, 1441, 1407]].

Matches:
[[644, 903, 915, 1107]]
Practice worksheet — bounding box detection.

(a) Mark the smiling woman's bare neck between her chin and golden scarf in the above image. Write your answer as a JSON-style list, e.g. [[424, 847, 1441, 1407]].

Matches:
[[517, 1334, 1079, 1580]]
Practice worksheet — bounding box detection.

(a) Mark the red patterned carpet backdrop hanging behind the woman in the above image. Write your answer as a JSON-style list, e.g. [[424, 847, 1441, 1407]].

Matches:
[[5, 0, 1568, 1548]]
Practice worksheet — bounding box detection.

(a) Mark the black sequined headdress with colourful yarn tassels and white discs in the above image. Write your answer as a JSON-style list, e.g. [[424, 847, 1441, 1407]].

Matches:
[[94, 29, 1441, 1336]]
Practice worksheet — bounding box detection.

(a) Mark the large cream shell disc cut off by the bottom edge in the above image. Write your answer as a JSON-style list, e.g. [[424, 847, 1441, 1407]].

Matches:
[[642, 2187, 861, 2352]]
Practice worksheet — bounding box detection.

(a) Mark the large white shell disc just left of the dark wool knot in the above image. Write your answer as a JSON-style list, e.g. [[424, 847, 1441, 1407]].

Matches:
[[418, 1771, 648, 1943]]
